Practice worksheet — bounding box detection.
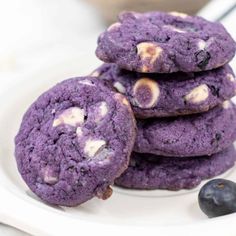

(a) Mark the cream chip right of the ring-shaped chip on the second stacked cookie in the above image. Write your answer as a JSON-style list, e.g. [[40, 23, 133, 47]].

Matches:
[[184, 84, 209, 103]]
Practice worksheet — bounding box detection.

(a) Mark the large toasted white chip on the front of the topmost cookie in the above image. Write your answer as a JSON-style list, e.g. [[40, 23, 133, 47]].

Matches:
[[137, 42, 163, 64]]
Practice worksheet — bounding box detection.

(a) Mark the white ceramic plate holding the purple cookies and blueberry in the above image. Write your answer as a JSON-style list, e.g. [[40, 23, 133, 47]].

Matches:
[[0, 54, 236, 236]]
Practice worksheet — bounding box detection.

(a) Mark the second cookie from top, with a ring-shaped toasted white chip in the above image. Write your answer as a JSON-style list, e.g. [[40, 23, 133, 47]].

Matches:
[[92, 64, 236, 118]]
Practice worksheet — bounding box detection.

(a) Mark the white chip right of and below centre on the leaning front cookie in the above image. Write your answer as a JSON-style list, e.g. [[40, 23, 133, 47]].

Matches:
[[84, 139, 106, 158]]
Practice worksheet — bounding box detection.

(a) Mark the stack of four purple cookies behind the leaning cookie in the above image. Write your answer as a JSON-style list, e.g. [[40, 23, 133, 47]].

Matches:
[[92, 12, 236, 190]]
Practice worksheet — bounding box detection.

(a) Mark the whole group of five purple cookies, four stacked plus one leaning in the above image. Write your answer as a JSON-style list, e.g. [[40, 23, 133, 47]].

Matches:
[[15, 12, 236, 206]]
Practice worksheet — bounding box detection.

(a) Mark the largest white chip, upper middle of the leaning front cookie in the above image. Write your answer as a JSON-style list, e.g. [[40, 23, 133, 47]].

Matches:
[[52, 107, 85, 127]]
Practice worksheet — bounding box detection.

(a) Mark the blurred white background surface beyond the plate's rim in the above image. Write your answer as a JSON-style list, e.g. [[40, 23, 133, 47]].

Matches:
[[0, 0, 236, 235]]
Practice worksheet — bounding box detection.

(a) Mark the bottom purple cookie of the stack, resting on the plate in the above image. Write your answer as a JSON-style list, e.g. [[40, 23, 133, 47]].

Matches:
[[115, 145, 236, 190]]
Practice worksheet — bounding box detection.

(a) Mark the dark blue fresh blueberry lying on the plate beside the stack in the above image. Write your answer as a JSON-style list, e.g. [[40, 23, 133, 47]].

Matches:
[[198, 179, 236, 218]]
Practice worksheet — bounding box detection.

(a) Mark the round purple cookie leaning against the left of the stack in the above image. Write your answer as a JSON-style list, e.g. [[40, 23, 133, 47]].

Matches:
[[15, 77, 136, 206]]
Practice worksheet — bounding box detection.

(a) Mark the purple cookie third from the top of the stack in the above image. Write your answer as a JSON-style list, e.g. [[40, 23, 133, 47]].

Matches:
[[134, 101, 236, 158]]
